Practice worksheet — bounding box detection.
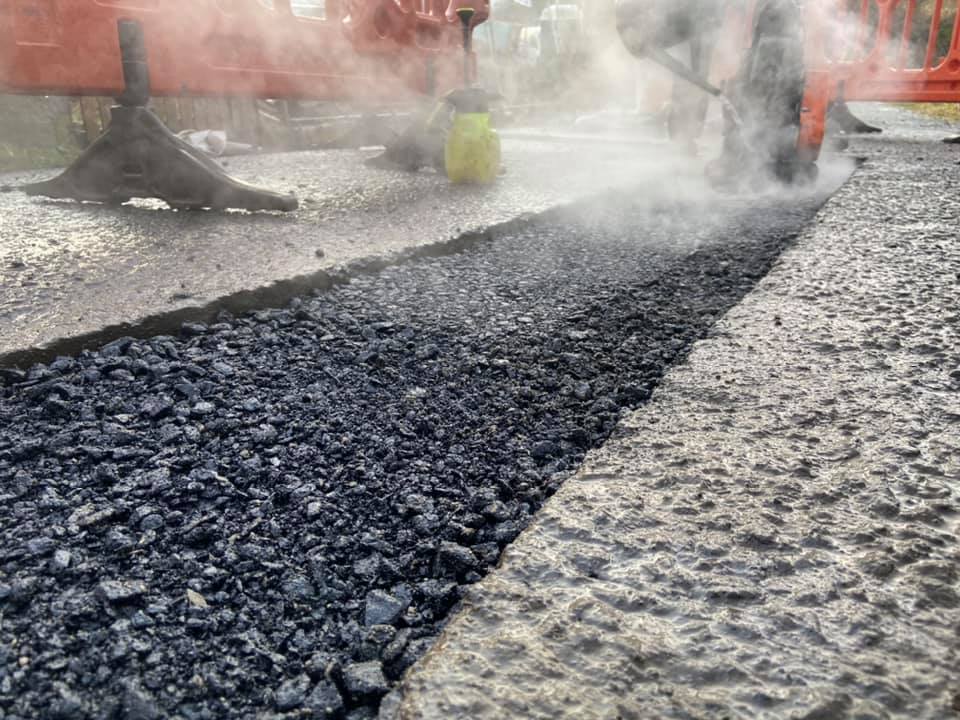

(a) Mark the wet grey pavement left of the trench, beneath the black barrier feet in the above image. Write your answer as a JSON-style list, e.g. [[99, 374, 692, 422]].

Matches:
[[0, 138, 669, 357]]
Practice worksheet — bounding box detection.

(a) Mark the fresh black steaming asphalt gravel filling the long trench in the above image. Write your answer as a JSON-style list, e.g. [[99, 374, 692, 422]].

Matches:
[[0, 181, 840, 720]]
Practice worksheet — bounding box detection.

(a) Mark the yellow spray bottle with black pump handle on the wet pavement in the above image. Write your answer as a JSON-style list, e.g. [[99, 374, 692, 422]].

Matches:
[[444, 8, 500, 184]]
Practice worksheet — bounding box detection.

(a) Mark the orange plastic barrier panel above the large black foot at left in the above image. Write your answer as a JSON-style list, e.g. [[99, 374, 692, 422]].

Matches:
[[0, 0, 489, 102]]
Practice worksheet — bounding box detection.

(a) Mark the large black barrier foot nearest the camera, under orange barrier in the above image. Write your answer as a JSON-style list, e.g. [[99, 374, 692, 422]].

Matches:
[[22, 105, 298, 211]]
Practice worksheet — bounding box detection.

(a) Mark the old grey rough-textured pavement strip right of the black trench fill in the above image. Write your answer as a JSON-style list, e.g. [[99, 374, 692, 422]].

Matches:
[[388, 110, 960, 720]]
